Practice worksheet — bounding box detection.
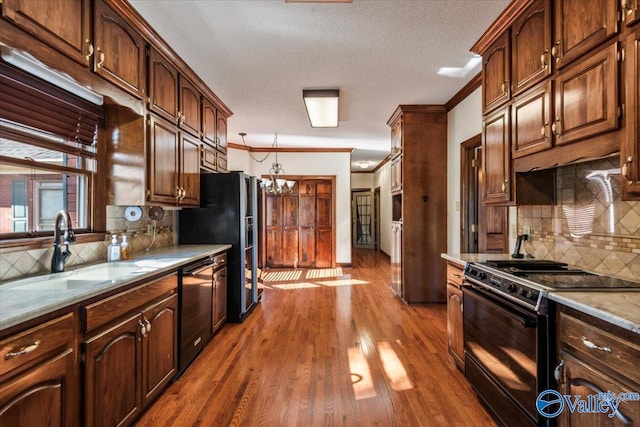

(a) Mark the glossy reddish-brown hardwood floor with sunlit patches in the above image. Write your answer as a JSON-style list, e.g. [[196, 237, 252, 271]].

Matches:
[[137, 249, 494, 427]]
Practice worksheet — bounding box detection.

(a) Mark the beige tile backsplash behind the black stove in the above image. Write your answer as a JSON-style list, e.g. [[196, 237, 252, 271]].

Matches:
[[518, 157, 640, 281]]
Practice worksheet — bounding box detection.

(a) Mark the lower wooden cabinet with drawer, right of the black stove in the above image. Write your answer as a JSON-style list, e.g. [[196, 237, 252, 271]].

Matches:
[[554, 306, 640, 427]]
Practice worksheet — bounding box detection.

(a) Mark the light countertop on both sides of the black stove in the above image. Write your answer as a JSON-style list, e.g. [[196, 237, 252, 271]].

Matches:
[[440, 253, 640, 334]]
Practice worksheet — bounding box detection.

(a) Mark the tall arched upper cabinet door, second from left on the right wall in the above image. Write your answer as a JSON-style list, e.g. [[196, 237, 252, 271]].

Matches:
[[511, 0, 551, 95]]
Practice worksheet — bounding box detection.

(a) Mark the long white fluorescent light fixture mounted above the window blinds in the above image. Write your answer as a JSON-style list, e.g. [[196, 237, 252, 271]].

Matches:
[[0, 45, 103, 105]]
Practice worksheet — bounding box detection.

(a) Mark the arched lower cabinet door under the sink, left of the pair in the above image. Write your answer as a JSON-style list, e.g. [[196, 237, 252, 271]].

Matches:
[[84, 314, 143, 427]]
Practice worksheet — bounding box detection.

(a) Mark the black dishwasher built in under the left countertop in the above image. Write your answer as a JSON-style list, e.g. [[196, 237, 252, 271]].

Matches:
[[178, 256, 214, 373]]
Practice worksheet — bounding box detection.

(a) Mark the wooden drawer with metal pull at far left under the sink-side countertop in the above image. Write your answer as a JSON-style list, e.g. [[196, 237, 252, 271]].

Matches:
[[0, 313, 73, 376]]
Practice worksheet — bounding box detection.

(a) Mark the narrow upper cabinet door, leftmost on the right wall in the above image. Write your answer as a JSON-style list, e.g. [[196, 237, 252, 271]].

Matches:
[[482, 31, 511, 113]]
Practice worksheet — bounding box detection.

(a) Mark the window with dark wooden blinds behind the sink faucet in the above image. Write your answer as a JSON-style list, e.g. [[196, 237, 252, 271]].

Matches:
[[0, 61, 105, 241]]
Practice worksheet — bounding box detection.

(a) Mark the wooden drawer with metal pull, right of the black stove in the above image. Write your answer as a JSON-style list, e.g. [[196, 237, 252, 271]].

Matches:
[[558, 312, 640, 383]]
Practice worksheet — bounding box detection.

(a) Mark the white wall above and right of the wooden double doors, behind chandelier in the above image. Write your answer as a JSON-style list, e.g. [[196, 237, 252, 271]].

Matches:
[[227, 149, 351, 264]]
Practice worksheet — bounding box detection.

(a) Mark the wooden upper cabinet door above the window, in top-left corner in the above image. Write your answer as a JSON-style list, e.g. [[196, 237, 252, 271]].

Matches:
[[2, 0, 93, 66]]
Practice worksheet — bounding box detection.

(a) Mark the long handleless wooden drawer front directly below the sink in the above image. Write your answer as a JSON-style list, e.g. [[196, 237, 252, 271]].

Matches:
[[81, 274, 178, 333]]
